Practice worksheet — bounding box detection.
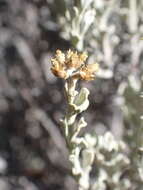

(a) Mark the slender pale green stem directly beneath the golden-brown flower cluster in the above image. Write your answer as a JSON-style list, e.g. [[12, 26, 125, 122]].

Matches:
[[64, 77, 87, 190]]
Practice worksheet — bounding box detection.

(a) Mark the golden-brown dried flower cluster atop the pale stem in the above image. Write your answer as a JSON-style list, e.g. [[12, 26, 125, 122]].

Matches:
[[51, 50, 98, 80]]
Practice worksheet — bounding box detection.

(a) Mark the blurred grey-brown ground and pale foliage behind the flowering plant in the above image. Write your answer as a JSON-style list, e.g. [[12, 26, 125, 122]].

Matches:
[[0, 0, 143, 190]]
